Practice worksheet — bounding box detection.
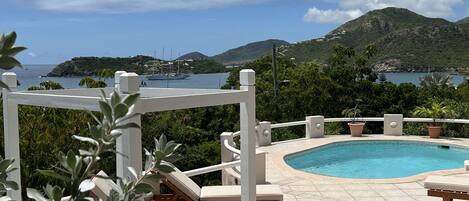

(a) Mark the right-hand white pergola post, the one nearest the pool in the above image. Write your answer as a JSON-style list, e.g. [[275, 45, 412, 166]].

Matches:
[[239, 69, 256, 201]]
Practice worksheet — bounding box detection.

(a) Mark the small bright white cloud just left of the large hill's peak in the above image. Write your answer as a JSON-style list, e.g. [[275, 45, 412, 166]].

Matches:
[[303, 7, 363, 23]]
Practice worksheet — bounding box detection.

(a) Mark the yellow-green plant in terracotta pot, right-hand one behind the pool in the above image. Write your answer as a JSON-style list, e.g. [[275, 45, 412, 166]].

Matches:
[[414, 102, 453, 138]]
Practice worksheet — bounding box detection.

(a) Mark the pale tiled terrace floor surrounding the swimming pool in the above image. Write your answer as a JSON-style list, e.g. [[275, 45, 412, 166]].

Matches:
[[259, 135, 469, 201]]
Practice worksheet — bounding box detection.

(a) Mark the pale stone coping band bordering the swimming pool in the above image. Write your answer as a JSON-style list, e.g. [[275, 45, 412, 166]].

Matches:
[[268, 135, 469, 184]]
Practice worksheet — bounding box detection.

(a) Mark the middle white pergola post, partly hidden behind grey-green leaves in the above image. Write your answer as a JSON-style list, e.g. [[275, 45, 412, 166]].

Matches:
[[116, 72, 143, 178]]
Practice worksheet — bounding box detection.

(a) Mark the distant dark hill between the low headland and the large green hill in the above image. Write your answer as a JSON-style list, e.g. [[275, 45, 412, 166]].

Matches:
[[210, 39, 289, 65]]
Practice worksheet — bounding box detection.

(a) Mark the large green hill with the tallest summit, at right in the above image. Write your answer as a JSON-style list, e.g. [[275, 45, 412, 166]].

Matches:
[[281, 7, 469, 71]]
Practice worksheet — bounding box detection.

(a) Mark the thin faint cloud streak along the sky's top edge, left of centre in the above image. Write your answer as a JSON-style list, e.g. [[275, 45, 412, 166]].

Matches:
[[34, 0, 269, 13]]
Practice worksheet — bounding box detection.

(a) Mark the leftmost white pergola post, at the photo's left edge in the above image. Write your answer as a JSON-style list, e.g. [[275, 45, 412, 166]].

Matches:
[[2, 72, 21, 201]]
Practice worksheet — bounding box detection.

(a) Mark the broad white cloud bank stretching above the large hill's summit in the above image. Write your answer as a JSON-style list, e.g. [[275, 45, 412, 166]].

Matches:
[[304, 0, 464, 23]]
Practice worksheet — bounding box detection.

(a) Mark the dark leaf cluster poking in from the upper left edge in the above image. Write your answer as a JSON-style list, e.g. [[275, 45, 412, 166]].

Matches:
[[0, 32, 26, 89]]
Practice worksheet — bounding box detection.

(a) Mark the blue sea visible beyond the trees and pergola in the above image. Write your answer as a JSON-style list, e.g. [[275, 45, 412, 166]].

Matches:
[[3, 65, 466, 90]]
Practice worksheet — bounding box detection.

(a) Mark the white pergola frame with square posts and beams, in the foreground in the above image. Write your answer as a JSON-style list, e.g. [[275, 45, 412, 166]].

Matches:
[[2, 69, 256, 201]]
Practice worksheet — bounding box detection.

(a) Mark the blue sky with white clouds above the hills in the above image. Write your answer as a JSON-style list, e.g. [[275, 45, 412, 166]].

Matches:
[[0, 0, 469, 64]]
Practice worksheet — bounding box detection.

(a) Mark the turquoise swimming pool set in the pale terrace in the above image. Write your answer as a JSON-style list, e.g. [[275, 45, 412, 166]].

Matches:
[[284, 140, 469, 179]]
